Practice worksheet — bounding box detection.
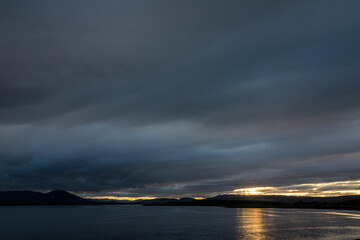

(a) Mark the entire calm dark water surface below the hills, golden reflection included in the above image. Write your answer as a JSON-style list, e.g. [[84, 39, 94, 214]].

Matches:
[[0, 206, 360, 240]]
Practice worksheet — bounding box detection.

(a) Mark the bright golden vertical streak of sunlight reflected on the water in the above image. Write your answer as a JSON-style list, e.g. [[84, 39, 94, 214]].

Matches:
[[237, 208, 266, 240]]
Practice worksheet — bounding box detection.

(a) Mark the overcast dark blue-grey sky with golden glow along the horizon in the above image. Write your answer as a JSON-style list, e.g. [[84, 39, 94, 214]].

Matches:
[[0, 0, 360, 197]]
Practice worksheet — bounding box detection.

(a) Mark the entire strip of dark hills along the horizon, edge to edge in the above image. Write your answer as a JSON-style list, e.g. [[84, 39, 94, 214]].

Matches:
[[0, 190, 360, 210]]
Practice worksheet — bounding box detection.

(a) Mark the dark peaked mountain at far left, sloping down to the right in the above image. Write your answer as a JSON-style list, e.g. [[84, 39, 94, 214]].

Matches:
[[0, 190, 91, 205]]
